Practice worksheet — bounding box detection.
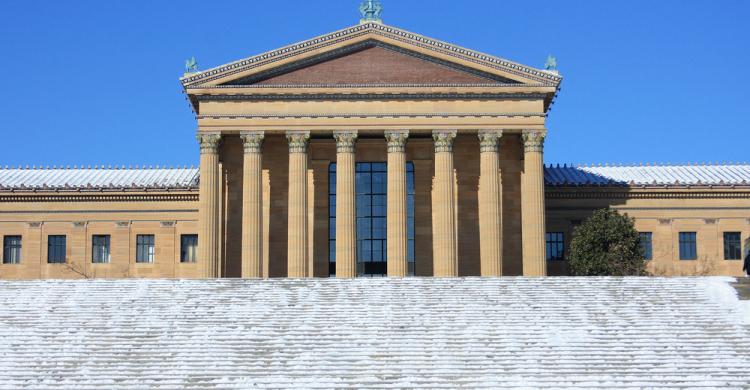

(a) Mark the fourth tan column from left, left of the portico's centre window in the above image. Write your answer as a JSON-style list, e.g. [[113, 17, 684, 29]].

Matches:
[[333, 131, 357, 278]]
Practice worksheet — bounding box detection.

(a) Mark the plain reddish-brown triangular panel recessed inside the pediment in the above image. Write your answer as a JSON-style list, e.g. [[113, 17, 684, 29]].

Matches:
[[222, 40, 520, 86]]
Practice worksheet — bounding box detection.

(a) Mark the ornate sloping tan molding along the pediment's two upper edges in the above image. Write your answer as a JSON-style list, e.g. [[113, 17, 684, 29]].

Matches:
[[181, 23, 562, 88]]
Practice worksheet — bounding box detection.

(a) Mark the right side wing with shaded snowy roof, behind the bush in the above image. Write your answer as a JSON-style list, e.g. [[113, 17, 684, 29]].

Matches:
[[545, 164, 750, 276]]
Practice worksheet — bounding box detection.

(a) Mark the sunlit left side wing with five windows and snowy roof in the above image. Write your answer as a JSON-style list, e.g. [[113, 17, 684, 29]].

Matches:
[[0, 168, 199, 279]]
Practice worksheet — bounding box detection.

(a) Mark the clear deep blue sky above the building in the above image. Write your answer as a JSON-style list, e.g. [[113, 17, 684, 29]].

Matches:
[[0, 0, 750, 165]]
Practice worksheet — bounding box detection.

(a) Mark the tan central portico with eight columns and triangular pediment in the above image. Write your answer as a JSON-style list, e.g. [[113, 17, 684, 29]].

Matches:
[[187, 22, 560, 278]]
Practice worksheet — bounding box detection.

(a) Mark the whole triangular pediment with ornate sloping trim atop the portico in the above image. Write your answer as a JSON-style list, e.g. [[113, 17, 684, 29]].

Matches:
[[181, 23, 562, 88]]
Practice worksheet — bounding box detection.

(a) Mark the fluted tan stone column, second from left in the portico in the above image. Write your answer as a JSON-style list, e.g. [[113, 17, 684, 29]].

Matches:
[[240, 131, 264, 278]]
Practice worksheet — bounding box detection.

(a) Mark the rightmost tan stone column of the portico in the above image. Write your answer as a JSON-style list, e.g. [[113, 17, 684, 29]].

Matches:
[[521, 130, 547, 276]]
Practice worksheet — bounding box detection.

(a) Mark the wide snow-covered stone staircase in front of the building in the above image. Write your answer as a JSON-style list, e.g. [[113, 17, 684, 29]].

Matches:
[[0, 278, 750, 389]]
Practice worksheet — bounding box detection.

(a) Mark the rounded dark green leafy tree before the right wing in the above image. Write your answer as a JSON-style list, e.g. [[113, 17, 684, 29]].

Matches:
[[568, 209, 647, 276]]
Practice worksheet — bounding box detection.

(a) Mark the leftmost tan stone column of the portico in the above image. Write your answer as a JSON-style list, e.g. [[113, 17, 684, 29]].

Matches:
[[197, 133, 221, 278]]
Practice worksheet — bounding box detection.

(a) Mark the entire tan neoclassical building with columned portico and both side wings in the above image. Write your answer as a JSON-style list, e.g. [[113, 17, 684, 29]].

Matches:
[[0, 12, 750, 278]]
